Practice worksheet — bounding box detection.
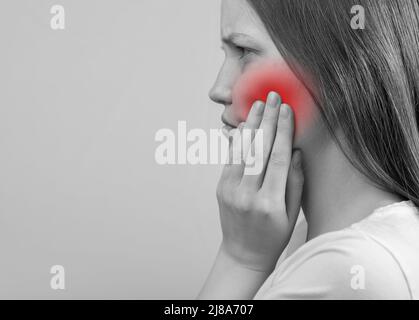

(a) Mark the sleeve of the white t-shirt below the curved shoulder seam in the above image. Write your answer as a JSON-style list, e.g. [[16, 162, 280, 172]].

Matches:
[[255, 231, 411, 300]]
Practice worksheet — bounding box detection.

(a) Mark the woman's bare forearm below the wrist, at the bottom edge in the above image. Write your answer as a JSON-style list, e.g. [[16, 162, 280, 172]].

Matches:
[[197, 246, 270, 300]]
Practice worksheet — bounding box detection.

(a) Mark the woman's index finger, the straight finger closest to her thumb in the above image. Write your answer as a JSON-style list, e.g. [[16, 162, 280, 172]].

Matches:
[[261, 104, 294, 196]]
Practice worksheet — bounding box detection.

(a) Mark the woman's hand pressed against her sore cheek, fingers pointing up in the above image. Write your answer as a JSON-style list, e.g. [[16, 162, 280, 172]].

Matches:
[[217, 92, 304, 273]]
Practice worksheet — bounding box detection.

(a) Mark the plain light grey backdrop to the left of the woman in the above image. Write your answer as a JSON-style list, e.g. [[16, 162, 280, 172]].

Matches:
[[0, 0, 223, 299]]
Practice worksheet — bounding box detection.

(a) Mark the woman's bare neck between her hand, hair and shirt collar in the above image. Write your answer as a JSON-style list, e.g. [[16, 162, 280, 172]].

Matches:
[[302, 136, 402, 240]]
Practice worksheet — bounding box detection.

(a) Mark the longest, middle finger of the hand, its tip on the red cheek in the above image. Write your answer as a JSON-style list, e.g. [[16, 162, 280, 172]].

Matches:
[[241, 92, 282, 190]]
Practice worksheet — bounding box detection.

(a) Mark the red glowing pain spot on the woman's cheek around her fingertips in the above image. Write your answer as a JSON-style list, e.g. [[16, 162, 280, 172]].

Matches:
[[232, 62, 314, 134]]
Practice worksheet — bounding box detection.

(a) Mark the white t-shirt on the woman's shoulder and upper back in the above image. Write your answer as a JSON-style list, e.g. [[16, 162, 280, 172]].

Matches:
[[254, 201, 419, 300]]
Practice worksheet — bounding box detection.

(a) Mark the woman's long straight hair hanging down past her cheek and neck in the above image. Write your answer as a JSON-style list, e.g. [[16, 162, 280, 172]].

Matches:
[[248, 0, 419, 206]]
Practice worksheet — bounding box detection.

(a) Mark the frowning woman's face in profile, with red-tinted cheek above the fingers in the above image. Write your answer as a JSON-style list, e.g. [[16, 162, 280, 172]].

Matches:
[[210, 0, 320, 148]]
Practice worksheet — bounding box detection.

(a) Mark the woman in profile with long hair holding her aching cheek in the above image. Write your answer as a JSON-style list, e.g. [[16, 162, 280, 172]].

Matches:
[[198, 0, 419, 299]]
